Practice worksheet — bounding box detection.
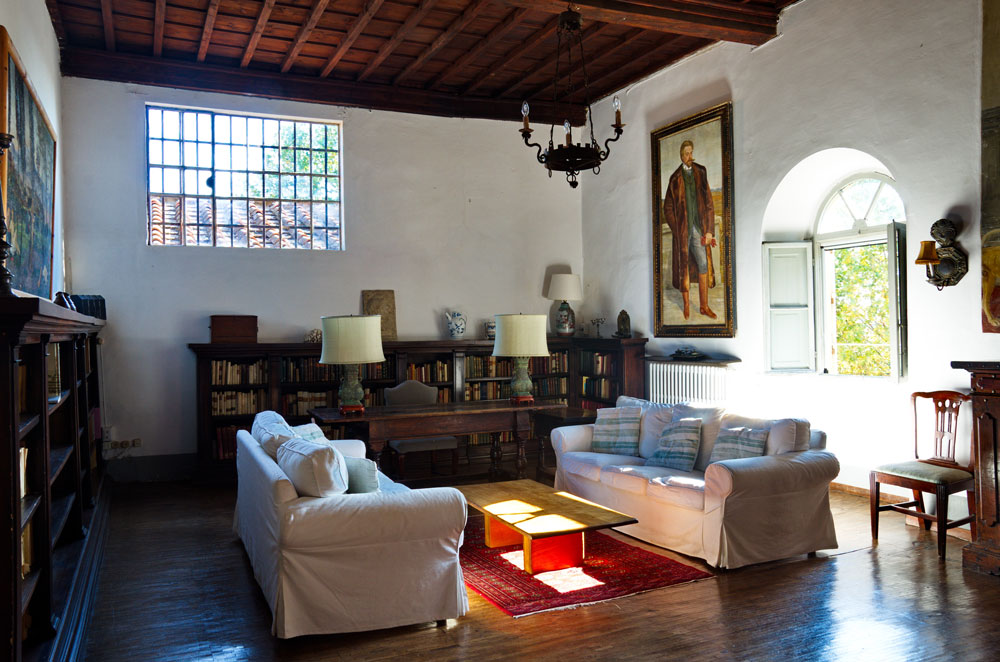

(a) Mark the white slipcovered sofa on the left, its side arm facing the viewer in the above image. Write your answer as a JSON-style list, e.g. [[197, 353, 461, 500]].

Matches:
[[233, 430, 469, 638]]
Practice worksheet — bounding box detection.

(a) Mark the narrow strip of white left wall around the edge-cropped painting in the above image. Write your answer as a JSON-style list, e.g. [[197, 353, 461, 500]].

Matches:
[[0, 0, 65, 294]]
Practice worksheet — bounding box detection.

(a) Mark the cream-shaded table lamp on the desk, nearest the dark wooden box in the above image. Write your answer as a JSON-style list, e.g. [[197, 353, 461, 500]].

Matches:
[[319, 315, 385, 415]]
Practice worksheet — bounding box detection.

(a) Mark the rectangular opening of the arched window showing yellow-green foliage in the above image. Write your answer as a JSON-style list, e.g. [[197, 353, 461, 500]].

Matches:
[[833, 244, 891, 376]]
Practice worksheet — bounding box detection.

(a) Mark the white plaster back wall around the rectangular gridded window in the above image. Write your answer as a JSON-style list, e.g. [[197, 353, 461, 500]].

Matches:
[[63, 78, 583, 455]]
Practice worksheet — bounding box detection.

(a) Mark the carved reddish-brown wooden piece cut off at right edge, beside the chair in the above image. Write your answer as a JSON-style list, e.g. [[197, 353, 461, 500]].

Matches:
[[951, 361, 1000, 575]]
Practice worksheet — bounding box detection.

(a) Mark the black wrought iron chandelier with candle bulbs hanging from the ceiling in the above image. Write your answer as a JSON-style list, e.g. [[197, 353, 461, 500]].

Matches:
[[521, 9, 625, 188]]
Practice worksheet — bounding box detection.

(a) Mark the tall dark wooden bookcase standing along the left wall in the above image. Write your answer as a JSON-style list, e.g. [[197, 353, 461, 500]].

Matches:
[[0, 298, 106, 661]]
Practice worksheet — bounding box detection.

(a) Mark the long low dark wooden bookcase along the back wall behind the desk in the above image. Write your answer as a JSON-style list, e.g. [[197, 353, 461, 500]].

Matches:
[[189, 336, 647, 477]]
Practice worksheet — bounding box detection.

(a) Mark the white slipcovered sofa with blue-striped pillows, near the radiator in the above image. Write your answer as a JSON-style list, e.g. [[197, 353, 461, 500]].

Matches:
[[551, 397, 840, 568]]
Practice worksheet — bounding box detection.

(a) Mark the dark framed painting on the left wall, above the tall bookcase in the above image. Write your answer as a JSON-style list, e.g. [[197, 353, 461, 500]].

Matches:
[[0, 26, 56, 298]]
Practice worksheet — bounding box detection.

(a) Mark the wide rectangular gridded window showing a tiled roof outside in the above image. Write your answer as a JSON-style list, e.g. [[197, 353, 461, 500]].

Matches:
[[146, 106, 342, 250]]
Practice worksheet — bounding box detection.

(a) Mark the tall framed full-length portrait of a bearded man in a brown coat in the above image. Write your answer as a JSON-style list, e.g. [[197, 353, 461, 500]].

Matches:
[[651, 102, 736, 338]]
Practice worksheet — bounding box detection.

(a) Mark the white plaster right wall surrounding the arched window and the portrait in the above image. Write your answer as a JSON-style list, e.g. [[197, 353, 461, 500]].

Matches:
[[578, 0, 1000, 486]]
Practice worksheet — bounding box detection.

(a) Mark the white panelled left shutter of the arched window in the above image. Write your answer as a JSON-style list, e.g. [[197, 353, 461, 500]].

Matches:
[[762, 241, 816, 370]]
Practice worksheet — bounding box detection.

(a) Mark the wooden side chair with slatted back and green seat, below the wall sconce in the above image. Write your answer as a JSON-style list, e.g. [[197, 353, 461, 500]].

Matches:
[[870, 391, 976, 558]]
